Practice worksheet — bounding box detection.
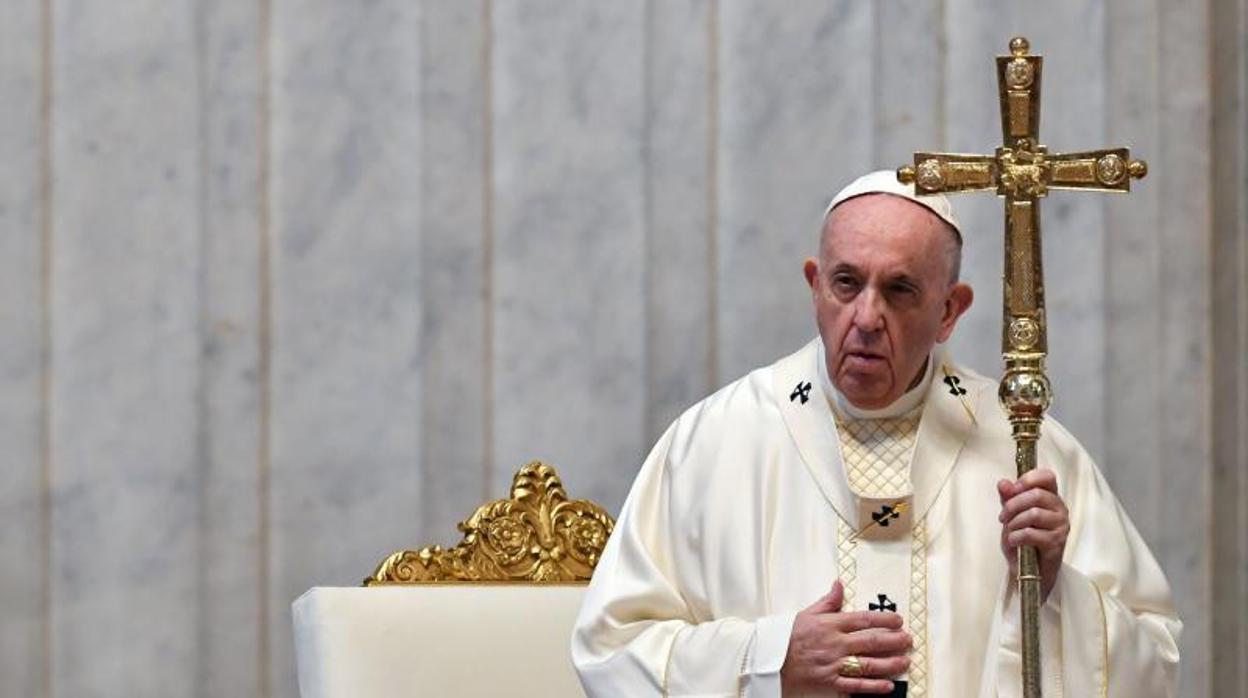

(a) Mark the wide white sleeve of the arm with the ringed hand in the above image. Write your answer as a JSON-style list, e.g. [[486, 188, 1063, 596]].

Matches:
[[572, 430, 794, 698]]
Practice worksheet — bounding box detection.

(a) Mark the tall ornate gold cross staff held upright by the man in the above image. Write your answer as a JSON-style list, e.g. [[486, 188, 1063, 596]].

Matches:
[[897, 36, 1148, 698]]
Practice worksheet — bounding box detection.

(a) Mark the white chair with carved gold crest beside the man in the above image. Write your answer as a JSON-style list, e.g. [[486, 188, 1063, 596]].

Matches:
[[292, 462, 614, 698]]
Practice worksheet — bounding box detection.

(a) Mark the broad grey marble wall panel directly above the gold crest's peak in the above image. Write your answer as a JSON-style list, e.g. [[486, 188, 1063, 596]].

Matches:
[[490, 0, 649, 509]]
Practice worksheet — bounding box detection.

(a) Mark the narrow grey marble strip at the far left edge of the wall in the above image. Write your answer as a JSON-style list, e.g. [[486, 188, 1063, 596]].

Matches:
[[0, 2, 47, 697]]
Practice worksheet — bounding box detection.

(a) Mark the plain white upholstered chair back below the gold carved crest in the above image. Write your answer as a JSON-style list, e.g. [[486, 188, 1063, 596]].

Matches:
[[292, 584, 585, 698]]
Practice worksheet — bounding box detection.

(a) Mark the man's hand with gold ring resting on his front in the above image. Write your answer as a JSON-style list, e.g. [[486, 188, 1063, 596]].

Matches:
[[780, 579, 912, 694]]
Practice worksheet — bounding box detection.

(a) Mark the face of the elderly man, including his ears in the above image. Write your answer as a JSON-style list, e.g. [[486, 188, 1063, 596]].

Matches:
[[805, 194, 973, 410]]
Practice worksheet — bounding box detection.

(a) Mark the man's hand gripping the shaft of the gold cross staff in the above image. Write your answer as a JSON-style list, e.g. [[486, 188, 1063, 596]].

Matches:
[[997, 468, 1071, 601]]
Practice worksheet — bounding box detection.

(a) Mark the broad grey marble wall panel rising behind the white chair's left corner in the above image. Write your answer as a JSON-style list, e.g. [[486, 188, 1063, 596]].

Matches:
[[267, 0, 422, 696]]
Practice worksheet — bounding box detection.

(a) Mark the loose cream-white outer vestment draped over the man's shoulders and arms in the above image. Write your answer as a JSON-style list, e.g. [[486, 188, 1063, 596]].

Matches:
[[572, 338, 1182, 698]]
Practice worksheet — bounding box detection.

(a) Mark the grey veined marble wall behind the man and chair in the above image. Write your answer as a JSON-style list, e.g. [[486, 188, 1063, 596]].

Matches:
[[0, 0, 1248, 697]]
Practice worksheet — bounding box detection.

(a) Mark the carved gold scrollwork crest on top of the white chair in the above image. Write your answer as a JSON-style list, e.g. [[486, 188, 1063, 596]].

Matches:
[[364, 461, 615, 586]]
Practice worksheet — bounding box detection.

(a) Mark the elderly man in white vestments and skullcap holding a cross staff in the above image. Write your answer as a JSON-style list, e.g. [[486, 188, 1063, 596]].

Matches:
[[572, 172, 1181, 698]]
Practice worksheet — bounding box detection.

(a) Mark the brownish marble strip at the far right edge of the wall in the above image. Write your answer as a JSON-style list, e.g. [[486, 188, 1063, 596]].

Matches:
[[1209, 0, 1248, 696]]
